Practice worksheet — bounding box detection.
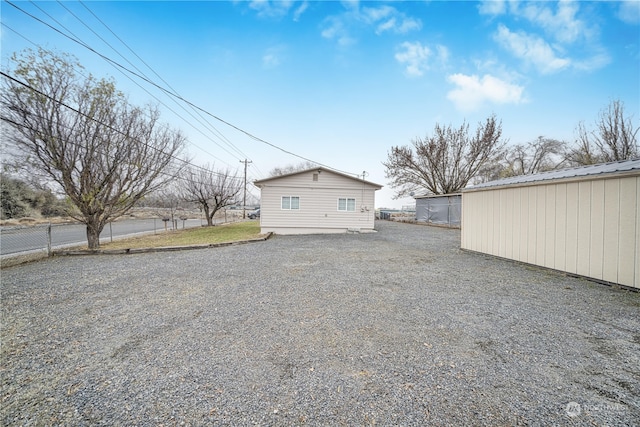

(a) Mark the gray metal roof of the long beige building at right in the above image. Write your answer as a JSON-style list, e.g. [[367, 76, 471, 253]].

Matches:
[[466, 159, 640, 190]]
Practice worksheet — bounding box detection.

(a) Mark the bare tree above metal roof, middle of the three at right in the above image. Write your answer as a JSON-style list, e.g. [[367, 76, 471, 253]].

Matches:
[[500, 136, 565, 177]]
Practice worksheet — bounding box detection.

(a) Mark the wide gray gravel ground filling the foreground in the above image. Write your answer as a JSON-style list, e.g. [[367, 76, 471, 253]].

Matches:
[[0, 222, 640, 426]]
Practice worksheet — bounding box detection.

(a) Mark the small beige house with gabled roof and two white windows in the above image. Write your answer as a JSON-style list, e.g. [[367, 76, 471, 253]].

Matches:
[[254, 167, 382, 234]]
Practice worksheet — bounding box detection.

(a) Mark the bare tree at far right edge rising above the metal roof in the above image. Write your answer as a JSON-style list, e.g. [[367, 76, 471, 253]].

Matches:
[[567, 100, 640, 165]]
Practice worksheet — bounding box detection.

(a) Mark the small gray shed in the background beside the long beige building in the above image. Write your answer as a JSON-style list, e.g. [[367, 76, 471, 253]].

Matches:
[[415, 193, 462, 228]]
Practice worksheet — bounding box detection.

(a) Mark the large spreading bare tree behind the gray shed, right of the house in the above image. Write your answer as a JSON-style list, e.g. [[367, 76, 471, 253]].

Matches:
[[383, 116, 505, 197]]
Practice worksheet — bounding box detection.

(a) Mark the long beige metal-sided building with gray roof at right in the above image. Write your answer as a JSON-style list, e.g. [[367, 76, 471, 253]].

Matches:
[[461, 160, 640, 288]]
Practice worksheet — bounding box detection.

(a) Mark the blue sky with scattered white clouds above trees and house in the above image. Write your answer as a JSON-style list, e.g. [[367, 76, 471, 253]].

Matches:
[[0, 1, 640, 207]]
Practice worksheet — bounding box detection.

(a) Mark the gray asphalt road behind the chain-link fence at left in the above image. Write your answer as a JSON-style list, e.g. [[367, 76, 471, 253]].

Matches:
[[0, 218, 202, 256]]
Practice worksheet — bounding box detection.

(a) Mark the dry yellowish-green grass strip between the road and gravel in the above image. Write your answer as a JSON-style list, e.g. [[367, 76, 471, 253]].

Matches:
[[100, 221, 265, 249]]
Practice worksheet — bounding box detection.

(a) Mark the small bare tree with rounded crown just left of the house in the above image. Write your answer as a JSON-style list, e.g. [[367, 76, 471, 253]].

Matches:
[[182, 165, 243, 226]]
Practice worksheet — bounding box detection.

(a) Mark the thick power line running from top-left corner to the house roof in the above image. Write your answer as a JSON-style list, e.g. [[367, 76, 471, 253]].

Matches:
[[5, 0, 357, 176]]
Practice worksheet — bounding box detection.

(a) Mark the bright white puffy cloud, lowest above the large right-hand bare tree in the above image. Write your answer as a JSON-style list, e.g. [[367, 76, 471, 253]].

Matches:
[[447, 74, 526, 111]]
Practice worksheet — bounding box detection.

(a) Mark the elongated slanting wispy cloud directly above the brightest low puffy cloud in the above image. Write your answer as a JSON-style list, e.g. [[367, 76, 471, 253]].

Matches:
[[494, 24, 571, 74]]
